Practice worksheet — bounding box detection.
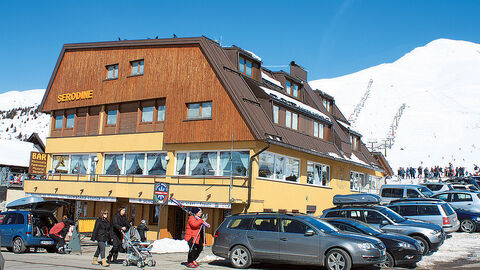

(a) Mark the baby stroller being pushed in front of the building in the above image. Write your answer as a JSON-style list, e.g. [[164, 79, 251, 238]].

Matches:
[[122, 226, 156, 268]]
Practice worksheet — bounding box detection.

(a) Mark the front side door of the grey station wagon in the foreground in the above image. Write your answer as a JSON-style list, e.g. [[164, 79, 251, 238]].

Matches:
[[279, 218, 321, 264]]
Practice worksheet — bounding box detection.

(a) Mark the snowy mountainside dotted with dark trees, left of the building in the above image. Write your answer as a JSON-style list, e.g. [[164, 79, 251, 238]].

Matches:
[[0, 89, 50, 142]]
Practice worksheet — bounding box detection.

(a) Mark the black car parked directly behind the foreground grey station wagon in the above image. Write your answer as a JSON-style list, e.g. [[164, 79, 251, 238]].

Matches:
[[323, 218, 422, 267]]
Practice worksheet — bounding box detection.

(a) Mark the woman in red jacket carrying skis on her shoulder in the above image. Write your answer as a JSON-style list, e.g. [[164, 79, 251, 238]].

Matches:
[[185, 207, 205, 268]]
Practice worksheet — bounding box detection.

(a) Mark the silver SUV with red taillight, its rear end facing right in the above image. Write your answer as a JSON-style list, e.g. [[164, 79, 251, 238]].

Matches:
[[387, 199, 460, 233]]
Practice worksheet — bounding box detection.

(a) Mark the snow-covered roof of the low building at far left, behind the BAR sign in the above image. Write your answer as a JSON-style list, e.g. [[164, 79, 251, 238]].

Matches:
[[0, 140, 38, 167]]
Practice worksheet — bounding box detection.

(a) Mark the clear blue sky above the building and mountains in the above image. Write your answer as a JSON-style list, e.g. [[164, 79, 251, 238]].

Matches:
[[0, 0, 480, 93]]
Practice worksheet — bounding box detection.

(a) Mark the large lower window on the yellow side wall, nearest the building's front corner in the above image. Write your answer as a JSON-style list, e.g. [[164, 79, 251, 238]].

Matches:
[[258, 152, 300, 182]]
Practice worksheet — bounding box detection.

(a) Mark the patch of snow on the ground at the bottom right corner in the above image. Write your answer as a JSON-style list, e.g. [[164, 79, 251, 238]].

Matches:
[[417, 233, 480, 269]]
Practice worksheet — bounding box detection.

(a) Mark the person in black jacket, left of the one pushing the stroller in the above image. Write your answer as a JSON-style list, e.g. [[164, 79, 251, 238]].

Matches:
[[92, 209, 112, 266]]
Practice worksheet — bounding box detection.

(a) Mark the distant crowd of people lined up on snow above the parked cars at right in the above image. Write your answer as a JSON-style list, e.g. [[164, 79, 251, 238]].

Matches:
[[397, 163, 480, 179]]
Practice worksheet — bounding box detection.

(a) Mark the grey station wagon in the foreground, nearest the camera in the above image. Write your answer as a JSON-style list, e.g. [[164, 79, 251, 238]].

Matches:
[[212, 213, 386, 270]]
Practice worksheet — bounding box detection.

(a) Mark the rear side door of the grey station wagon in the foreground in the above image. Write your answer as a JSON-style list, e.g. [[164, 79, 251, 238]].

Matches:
[[247, 217, 280, 260]]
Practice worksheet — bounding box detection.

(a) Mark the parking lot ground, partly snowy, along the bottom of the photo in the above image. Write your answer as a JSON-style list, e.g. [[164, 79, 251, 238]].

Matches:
[[2, 230, 480, 270]]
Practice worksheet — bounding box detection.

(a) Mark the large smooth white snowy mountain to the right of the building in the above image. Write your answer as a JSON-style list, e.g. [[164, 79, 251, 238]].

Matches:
[[310, 39, 480, 171]]
